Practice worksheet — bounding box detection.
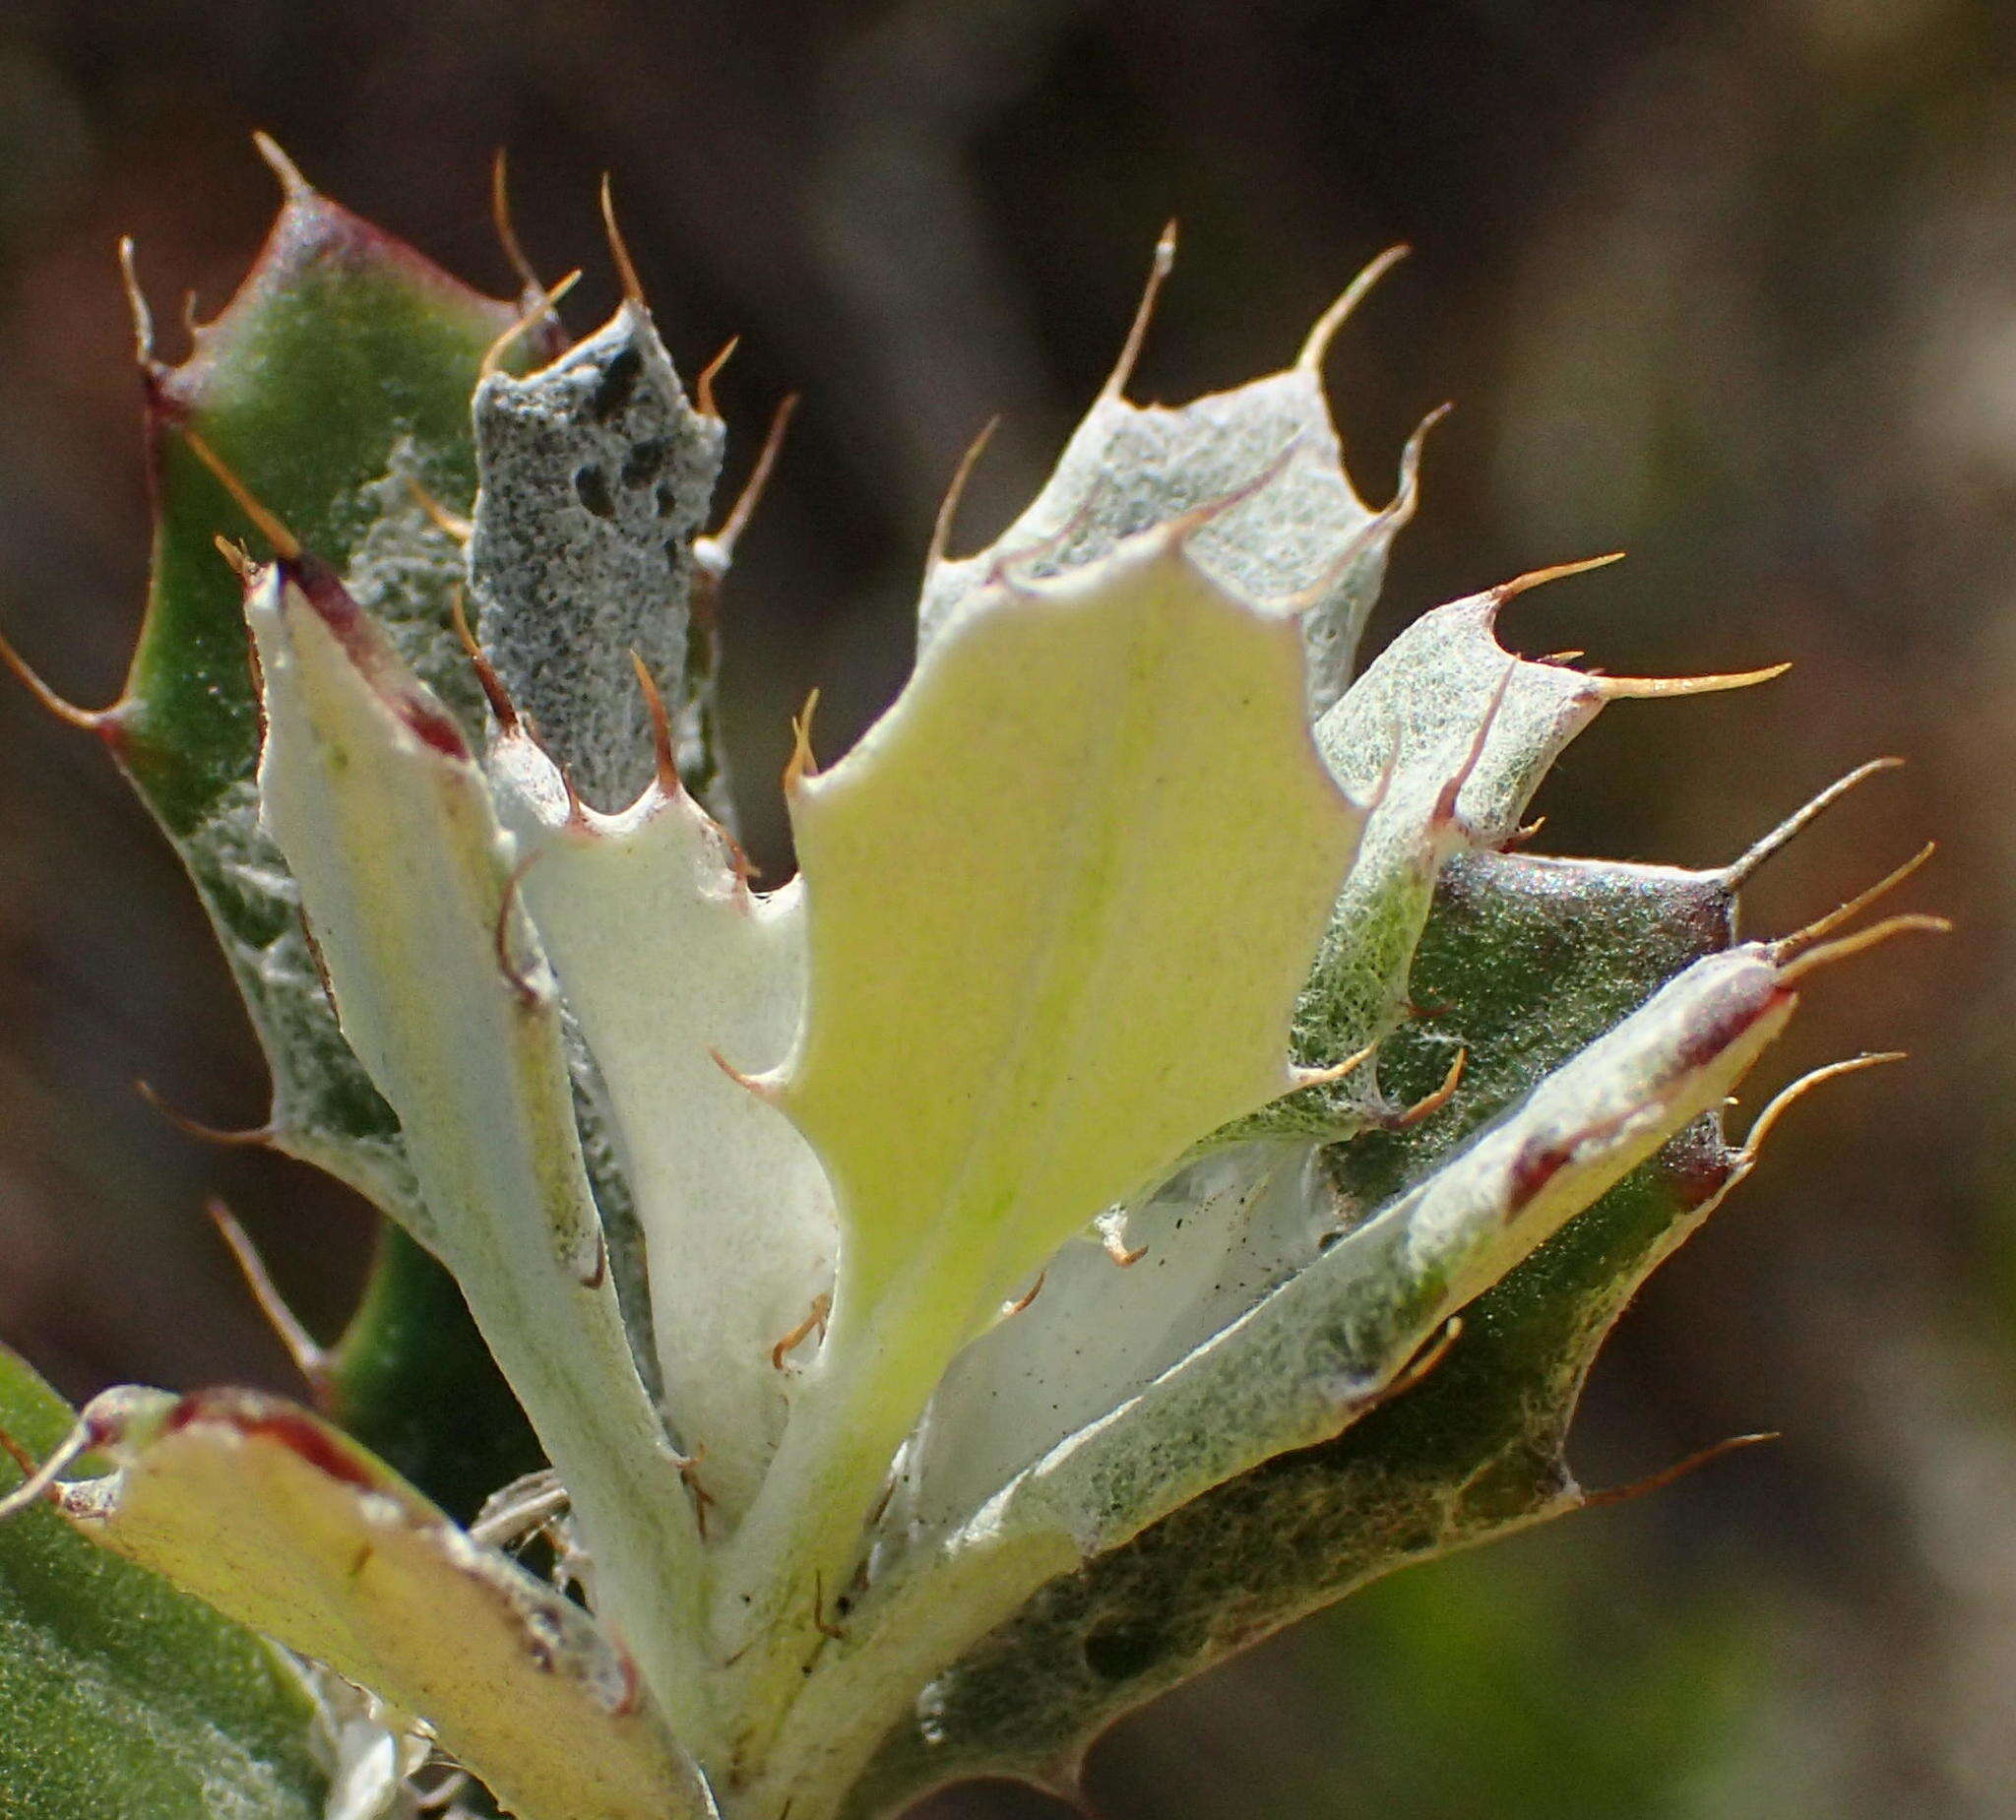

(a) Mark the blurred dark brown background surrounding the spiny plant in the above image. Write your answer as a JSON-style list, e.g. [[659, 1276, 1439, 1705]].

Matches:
[[0, 0, 1991, 1820]]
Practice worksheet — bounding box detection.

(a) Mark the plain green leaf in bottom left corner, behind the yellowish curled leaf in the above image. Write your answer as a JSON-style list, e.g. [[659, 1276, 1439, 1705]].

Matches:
[[0, 1349, 327, 1820]]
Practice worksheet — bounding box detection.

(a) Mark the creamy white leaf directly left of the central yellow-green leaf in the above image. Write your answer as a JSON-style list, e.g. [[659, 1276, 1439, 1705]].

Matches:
[[490, 729, 839, 1534]]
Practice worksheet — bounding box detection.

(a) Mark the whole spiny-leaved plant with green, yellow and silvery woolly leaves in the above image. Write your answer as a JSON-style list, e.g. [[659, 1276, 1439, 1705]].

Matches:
[[0, 145, 1933, 1820]]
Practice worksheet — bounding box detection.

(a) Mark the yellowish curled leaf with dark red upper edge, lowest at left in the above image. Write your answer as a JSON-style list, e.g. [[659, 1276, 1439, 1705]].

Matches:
[[60, 1391, 710, 1820]]
